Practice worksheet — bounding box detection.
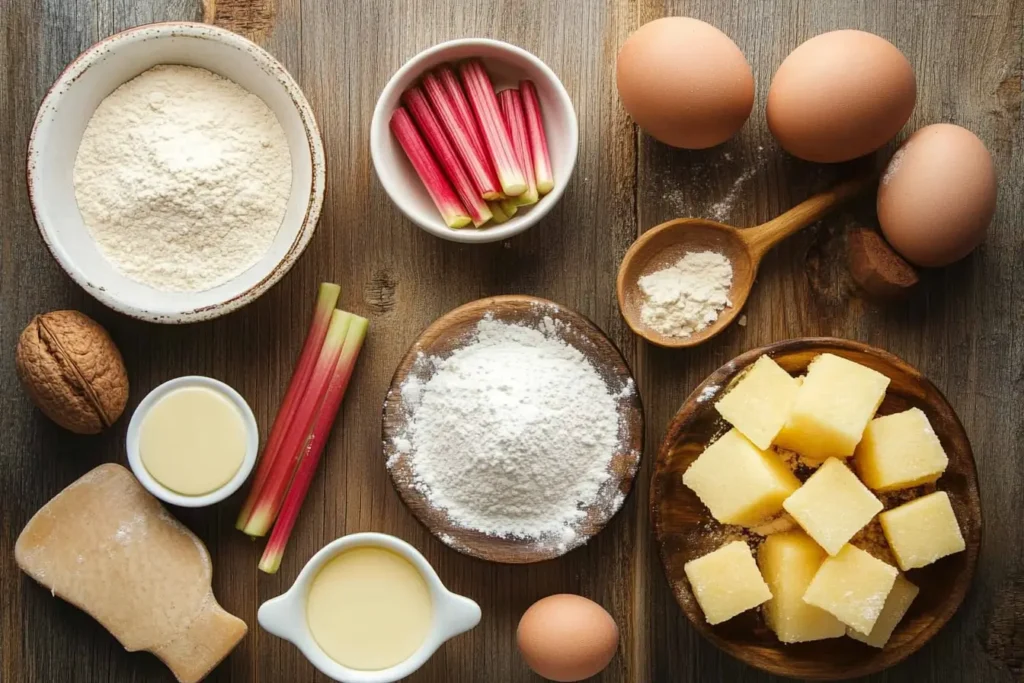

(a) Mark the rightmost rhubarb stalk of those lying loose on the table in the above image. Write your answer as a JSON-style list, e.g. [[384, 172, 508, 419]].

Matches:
[[259, 315, 370, 573]]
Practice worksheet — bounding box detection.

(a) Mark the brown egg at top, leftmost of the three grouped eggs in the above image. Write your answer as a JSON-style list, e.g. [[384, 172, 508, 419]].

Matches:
[[615, 16, 754, 150]]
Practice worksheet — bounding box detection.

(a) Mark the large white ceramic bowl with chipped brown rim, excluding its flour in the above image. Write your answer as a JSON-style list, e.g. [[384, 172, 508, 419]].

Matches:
[[28, 22, 325, 323]]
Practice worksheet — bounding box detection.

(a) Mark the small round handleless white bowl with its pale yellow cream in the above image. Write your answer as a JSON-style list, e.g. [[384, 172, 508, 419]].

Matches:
[[126, 375, 259, 508]]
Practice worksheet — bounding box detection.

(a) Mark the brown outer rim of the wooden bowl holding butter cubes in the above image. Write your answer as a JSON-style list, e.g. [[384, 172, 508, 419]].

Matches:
[[648, 337, 984, 681]]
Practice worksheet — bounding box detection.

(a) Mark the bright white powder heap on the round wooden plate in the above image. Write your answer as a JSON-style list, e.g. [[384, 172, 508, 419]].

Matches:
[[389, 316, 635, 546]]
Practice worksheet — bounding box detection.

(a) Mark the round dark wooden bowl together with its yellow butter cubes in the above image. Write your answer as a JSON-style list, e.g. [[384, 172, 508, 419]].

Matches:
[[650, 338, 981, 680]]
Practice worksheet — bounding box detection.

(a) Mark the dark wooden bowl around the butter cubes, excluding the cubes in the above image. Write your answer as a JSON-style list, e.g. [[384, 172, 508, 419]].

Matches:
[[650, 338, 981, 680]]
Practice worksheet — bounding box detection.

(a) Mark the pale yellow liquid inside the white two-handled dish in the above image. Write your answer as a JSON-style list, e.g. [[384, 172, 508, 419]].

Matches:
[[306, 548, 431, 671]]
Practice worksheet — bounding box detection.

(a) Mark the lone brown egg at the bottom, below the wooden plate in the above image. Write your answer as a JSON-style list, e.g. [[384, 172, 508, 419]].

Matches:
[[516, 594, 618, 682]]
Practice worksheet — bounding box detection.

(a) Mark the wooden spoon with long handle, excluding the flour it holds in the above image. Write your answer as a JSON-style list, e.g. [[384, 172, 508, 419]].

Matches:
[[616, 176, 876, 348]]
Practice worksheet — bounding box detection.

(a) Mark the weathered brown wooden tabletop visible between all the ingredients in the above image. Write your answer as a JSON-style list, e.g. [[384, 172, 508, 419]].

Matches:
[[0, 0, 1024, 683]]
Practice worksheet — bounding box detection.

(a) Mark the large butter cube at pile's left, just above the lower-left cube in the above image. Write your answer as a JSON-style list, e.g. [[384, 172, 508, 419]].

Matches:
[[683, 429, 800, 526]]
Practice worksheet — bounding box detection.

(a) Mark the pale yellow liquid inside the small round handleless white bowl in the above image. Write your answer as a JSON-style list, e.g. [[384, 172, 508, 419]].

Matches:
[[138, 387, 246, 496]]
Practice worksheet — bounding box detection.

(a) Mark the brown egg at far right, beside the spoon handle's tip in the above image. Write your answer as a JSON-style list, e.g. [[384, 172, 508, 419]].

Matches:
[[878, 123, 995, 267]]
